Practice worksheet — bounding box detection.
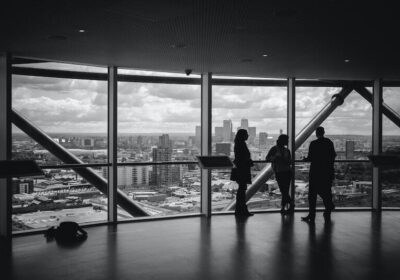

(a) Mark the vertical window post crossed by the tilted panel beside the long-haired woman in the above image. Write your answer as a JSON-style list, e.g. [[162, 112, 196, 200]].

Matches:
[[201, 73, 212, 217]]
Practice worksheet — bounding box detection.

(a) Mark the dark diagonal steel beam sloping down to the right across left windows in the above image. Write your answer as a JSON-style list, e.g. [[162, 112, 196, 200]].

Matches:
[[11, 109, 149, 217]]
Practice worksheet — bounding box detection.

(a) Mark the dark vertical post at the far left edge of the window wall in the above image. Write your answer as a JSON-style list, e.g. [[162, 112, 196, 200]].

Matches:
[[0, 53, 12, 240]]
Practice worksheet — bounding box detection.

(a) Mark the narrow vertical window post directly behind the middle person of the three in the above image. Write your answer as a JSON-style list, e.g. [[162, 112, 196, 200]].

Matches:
[[287, 78, 296, 208]]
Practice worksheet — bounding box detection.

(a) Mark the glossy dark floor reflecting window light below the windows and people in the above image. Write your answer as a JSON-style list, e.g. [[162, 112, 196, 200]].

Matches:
[[2, 211, 400, 280]]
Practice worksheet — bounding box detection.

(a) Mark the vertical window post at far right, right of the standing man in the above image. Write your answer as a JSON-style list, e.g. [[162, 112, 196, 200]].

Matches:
[[372, 79, 383, 211]]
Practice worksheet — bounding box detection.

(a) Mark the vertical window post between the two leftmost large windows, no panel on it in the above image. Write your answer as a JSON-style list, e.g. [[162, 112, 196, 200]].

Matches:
[[108, 66, 118, 223]]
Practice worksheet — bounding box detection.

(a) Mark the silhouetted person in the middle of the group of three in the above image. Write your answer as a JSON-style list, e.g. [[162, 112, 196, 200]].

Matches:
[[265, 134, 294, 214]]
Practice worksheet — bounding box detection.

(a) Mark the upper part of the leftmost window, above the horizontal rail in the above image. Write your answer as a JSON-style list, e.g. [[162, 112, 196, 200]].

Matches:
[[12, 75, 107, 164]]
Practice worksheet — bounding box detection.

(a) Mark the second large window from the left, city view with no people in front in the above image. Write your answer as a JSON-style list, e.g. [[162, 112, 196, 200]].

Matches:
[[118, 79, 201, 219]]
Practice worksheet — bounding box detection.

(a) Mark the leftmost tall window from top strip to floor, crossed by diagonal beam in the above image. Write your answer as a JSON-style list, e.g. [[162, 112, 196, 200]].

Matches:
[[12, 63, 108, 231]]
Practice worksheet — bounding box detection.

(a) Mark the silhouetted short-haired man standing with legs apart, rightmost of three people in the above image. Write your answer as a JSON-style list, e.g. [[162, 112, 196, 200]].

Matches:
[[302, 126, 336, 222]]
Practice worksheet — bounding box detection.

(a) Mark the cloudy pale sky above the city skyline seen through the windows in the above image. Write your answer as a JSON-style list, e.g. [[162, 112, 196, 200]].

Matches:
[[12, 64, 400, 135]]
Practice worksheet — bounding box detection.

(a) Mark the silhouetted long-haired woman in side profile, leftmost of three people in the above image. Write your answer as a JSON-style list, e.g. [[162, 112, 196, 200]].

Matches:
[[231, 129, 254, 216]]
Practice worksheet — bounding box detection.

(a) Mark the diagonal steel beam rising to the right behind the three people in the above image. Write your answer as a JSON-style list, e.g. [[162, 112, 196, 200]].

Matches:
[[225, 86, 353, 210]]
